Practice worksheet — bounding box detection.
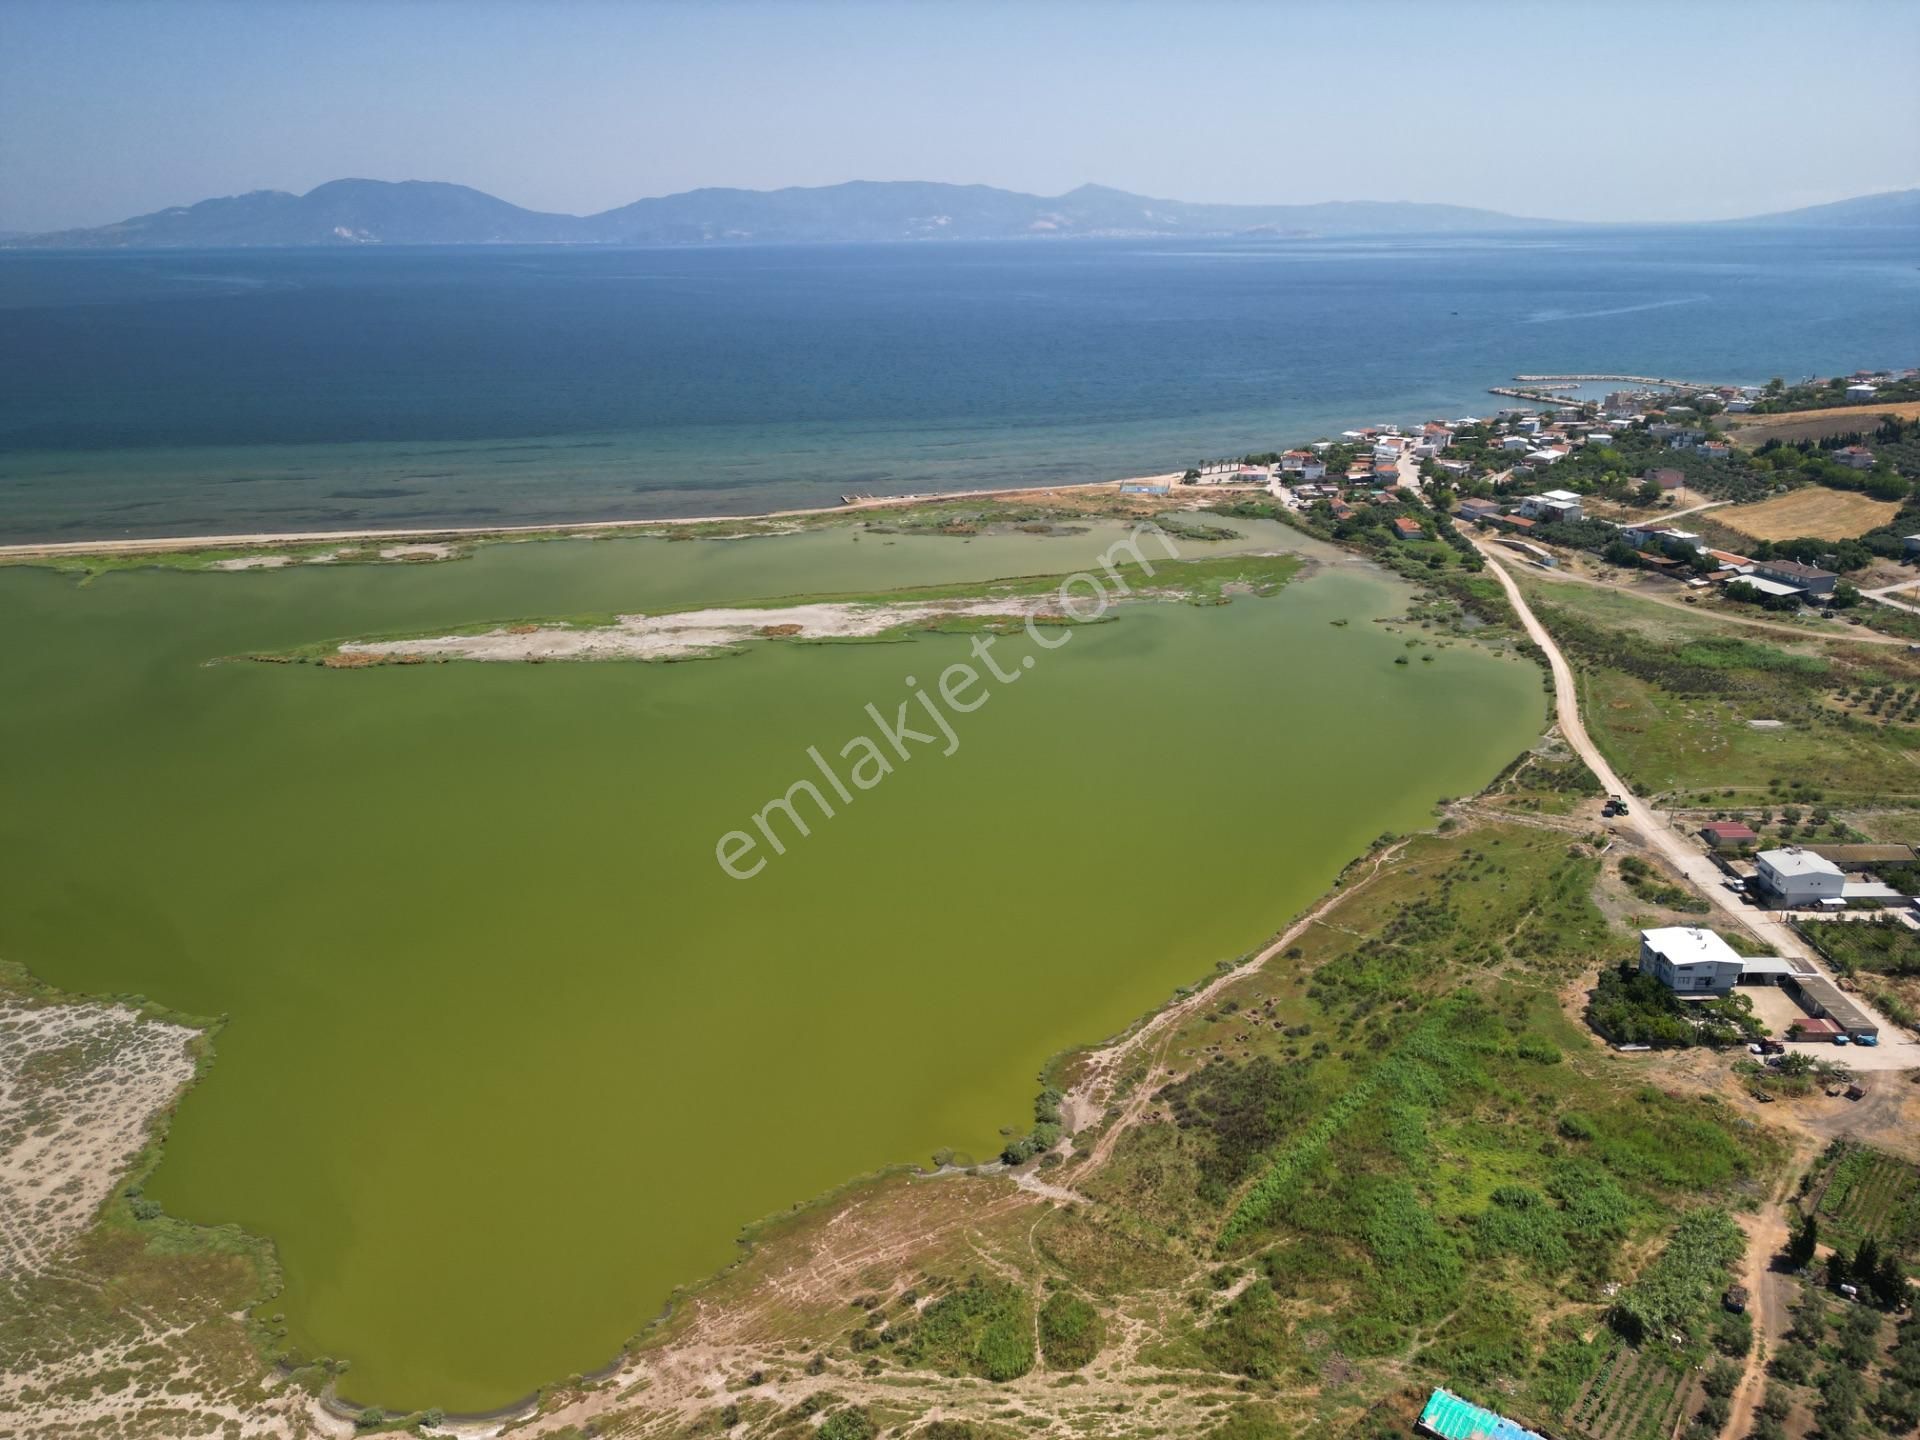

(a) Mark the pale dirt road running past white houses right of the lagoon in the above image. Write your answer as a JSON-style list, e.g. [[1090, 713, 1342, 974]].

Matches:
[[1459, 526, 1920, 1069]]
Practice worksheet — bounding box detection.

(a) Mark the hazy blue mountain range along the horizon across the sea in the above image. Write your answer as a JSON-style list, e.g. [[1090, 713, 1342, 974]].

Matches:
[[0, 180, 1920, 250]]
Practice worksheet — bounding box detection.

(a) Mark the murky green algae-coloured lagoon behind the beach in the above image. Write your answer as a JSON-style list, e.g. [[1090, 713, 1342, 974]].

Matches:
[[0, 520, 1544, 1411]]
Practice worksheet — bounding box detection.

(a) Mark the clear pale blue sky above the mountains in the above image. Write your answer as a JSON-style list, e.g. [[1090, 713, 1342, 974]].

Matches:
[[0, 0, 1920, 228]]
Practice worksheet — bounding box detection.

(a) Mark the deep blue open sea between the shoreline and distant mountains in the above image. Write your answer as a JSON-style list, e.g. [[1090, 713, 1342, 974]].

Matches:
[[0, 227, 1920, 541]]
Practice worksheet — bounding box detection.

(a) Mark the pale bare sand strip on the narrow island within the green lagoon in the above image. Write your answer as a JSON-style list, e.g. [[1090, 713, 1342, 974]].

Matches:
[[340, 595, 1060, 660]]
